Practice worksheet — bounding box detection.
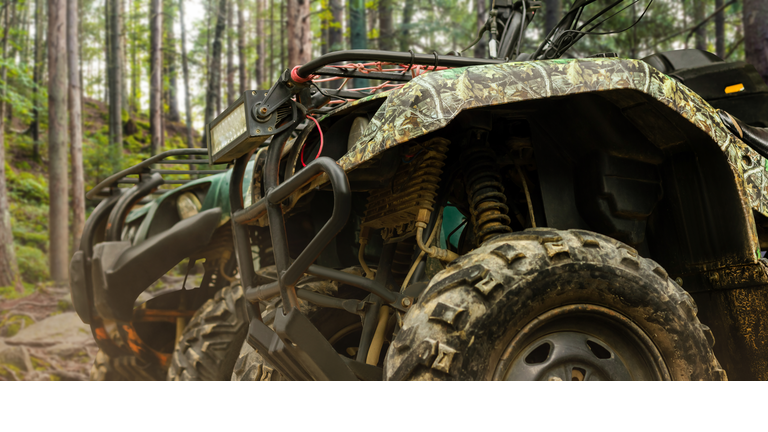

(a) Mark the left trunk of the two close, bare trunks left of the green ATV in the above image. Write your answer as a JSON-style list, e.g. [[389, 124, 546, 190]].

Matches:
[[48, 0, 69, 285]]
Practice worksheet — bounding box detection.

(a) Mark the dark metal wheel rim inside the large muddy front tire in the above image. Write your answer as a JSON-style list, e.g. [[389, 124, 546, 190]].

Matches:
[[493, 304, 670, 381]]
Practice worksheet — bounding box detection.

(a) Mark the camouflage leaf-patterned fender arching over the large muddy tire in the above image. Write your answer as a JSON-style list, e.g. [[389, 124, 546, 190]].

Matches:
[[320, 58, 768, 221]]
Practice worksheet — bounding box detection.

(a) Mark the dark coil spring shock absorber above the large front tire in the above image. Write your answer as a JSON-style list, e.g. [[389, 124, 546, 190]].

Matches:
[[463, 129, 512, 246]]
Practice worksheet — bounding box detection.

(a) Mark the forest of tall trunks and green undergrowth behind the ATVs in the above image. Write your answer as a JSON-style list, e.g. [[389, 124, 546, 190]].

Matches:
[[0, 0, 768, 300]]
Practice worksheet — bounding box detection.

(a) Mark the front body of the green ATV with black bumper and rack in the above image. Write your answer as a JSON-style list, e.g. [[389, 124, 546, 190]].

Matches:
[[70, 150, 253, 379]]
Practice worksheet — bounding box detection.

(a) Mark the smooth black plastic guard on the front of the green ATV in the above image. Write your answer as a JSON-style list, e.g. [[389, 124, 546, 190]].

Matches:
[[91, 208, 221, 321]]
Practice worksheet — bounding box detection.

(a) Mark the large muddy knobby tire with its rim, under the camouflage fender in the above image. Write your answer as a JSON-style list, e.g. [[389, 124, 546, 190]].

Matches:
[[384, 228, 726, 381]]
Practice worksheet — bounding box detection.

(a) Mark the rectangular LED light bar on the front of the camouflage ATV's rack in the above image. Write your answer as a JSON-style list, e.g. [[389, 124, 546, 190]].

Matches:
[[205, 90, 285, 164]]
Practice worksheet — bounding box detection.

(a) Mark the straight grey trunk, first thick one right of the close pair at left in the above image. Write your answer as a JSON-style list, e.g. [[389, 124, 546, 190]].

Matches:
[[108, 0, 123, 165]]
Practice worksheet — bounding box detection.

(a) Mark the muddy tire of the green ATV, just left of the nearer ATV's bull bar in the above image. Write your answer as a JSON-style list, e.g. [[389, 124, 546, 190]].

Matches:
[[168, 284, 248, 381]]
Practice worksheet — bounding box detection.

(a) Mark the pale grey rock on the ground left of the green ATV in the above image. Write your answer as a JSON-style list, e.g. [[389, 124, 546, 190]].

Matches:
[[5, 312, 93, 347]]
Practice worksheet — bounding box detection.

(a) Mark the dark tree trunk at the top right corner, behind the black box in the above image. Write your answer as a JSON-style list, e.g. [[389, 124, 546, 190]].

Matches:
[[742, 0, 768, 84]]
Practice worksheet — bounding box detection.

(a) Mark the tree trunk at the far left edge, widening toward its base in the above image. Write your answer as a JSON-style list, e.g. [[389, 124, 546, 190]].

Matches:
[[0, 5, 22, 293]]
